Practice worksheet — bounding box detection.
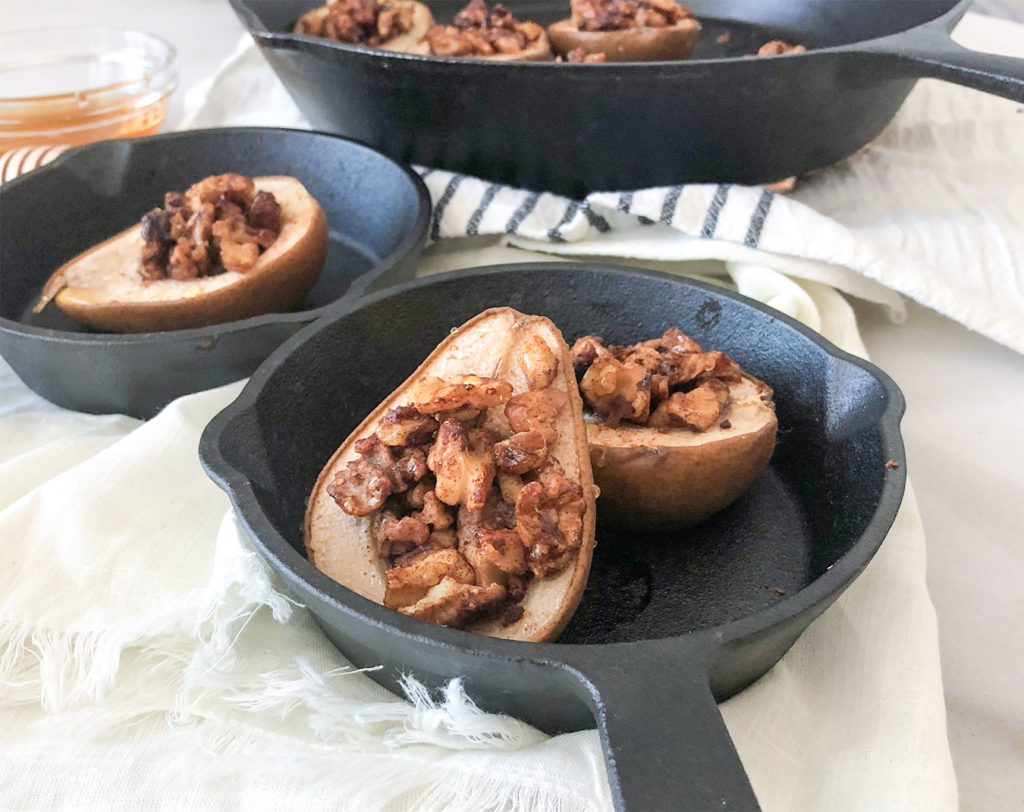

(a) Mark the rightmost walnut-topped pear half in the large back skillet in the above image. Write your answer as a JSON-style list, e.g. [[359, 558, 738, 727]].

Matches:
[[548, 0, 700, 62]]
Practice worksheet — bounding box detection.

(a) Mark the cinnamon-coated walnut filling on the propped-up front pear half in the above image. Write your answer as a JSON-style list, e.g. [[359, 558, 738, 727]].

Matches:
[[327, 366, 586, 628]]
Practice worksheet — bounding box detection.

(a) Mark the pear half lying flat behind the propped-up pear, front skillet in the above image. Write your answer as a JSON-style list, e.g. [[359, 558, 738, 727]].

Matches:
[[572, 328, 778, 532]]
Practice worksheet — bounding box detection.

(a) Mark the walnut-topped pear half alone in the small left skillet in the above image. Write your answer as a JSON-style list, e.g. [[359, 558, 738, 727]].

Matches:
[[35, 175, 328, 333]]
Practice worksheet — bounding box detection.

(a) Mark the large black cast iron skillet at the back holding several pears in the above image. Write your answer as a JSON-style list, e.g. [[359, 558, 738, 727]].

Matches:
[[230, 0, 1024, 197]]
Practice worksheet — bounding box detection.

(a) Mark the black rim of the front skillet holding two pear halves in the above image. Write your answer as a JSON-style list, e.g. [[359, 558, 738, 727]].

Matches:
[[199, 262, 906, 667]]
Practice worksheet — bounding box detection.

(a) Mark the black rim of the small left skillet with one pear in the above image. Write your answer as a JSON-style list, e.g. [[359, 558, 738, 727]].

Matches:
[[0, 127, 432, 345]]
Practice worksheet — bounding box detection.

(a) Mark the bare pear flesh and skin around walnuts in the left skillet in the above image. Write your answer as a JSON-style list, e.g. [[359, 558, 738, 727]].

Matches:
[[35, 175, 328, 333]]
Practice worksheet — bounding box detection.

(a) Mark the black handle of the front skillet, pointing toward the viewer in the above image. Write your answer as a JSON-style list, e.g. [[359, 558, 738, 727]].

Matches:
[[573, 638, 761, 812]]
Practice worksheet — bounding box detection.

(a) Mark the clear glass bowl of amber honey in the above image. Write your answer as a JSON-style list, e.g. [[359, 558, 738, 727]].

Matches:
[[0, 28, 177, 154]]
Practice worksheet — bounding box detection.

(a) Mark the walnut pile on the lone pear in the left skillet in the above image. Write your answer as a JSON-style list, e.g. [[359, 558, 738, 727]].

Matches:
[[139, 174, 281, 282]]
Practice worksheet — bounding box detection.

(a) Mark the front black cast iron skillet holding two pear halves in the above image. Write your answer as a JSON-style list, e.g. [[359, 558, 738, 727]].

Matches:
[[200, 263, 906, 810]]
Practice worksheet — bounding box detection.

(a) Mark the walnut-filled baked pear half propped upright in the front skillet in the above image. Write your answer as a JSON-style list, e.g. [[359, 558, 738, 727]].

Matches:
[[304, 307, 595, 641]]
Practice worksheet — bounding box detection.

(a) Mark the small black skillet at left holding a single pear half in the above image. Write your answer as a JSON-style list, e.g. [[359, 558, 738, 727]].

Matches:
[[0, 128, 430, 418]]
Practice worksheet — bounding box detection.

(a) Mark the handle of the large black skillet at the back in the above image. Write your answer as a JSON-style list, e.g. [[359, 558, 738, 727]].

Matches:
[[858, 19, 1024, 101]]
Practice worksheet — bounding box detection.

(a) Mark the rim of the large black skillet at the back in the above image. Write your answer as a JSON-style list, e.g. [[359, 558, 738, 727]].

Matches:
[[228, 0, 974, 71]]
